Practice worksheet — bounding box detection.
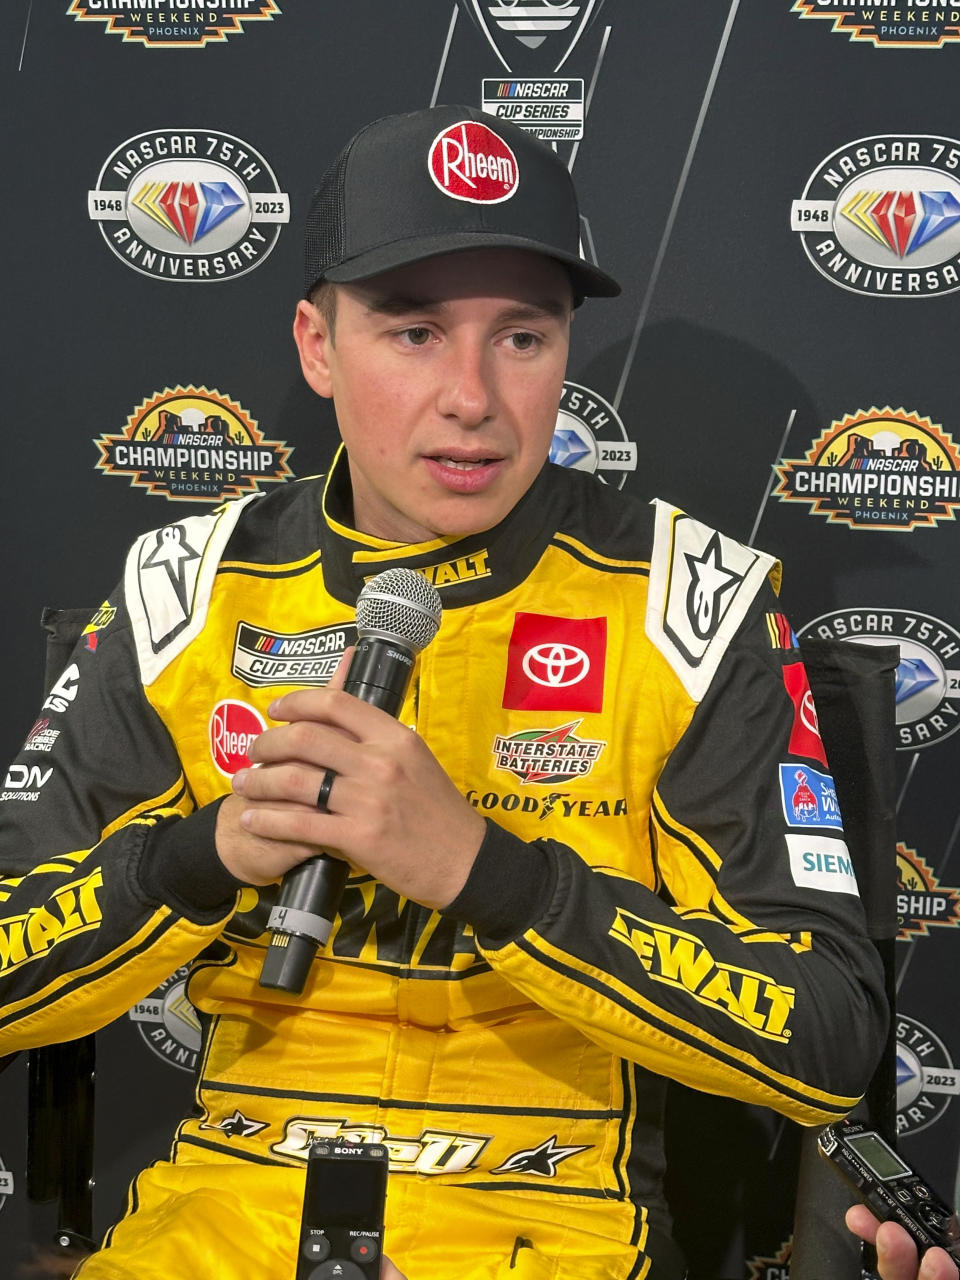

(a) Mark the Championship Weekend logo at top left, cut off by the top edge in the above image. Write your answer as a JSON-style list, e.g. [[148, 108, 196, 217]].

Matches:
[[67, 0, 280, 49]]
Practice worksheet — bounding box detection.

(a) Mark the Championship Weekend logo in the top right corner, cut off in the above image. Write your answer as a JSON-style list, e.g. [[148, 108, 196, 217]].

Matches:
[[794, 0, 960, 49]]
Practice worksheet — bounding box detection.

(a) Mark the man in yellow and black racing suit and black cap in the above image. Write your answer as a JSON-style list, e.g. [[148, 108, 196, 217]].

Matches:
[[0, 106, 884, 1280]]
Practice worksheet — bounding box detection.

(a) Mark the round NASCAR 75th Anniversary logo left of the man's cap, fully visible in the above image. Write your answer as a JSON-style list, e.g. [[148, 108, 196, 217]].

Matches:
[[87, 129, 291, 284]]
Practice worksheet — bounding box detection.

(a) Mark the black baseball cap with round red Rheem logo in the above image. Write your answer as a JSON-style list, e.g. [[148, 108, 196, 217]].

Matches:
[[305, 106, 620, 301]]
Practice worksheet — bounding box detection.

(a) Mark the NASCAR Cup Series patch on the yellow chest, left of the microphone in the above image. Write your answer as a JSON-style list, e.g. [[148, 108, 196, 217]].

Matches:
[[230, 622, 357, 689]]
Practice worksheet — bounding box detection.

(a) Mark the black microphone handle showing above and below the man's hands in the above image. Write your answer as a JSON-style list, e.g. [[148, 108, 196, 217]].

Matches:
[[260, 636, 413, 995]]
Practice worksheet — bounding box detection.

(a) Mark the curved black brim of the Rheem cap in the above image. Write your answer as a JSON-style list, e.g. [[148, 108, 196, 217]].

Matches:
[[316, 230, 621, 298]]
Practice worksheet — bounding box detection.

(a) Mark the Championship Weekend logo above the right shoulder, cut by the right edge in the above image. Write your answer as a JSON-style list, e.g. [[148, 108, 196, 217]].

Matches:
[[773, 408, 960, 532]]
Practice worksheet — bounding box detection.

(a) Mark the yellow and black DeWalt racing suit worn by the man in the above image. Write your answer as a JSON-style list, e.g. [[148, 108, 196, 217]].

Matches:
[[0, 454, 886, 1280]]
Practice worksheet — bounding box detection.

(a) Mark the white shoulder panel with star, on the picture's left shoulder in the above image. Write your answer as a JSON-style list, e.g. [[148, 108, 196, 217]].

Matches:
[[123, 493, 259, 685]]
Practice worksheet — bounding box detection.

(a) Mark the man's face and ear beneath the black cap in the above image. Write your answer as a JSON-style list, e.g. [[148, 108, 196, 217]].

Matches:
[[294, 250, 572, 543]]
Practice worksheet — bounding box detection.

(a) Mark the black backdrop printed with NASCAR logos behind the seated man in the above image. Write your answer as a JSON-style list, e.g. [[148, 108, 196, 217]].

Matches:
[[0, 0, 960, 1280]]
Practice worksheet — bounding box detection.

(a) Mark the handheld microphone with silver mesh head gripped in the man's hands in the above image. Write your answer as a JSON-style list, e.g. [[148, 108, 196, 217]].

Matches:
[[260, 568, 442, 995]]
